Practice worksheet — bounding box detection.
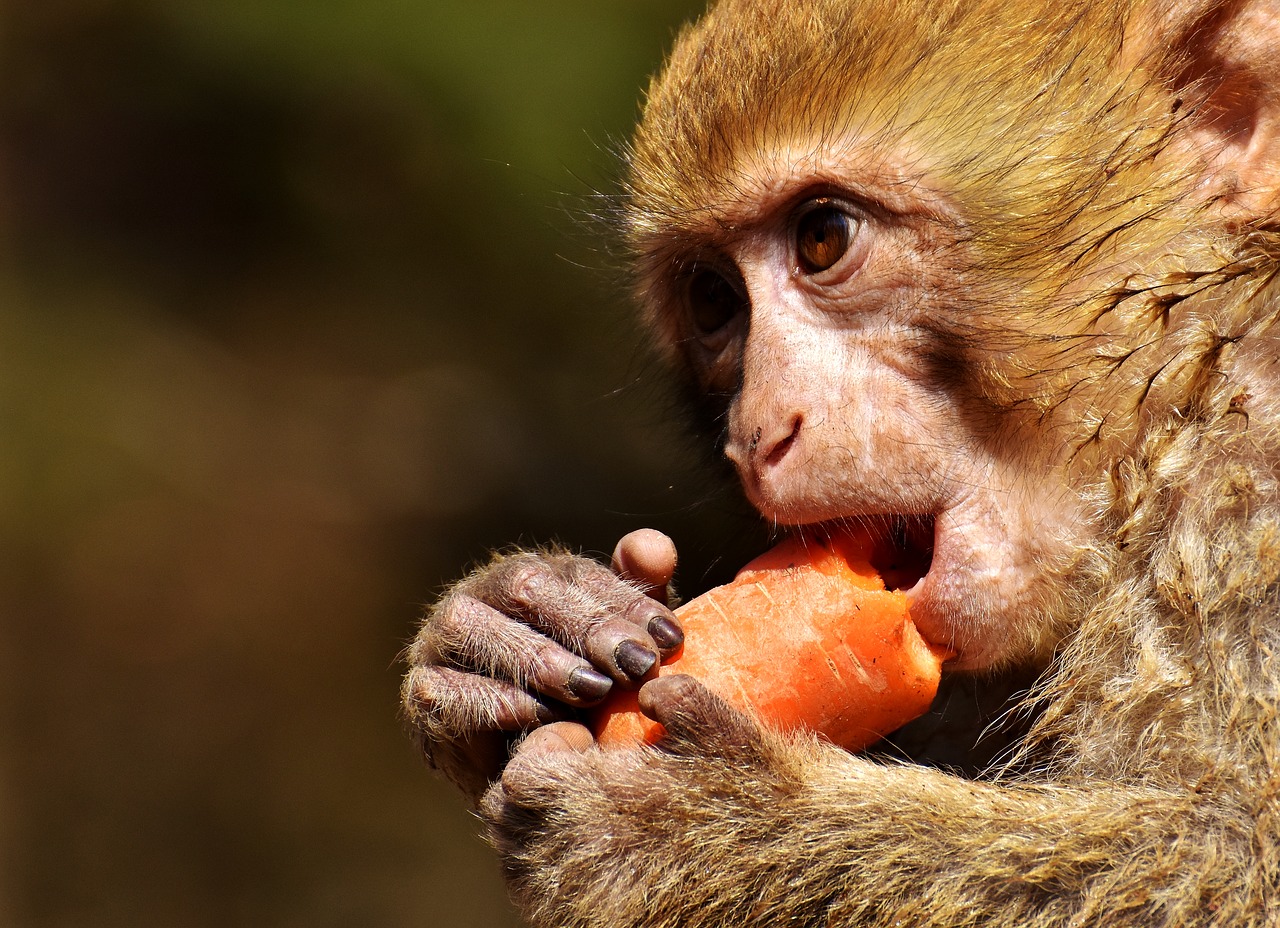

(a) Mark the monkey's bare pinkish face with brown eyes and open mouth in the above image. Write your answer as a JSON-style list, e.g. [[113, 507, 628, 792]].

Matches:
[[634, 142, 1088, 667]]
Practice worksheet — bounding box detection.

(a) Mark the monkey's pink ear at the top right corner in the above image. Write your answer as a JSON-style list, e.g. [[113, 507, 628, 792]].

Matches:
[[1123, 0, 1280, 218]]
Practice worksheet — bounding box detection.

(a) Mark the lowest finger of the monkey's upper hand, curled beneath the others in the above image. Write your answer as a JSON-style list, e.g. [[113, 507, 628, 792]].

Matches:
[[404, 666, 558, 737]]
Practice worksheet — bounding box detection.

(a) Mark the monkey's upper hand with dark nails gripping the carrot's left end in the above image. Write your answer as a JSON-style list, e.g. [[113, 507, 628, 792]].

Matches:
[[402, 529, 684, 800]]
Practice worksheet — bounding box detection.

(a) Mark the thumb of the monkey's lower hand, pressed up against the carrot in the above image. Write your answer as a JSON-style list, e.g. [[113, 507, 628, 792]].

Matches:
[[639, 673, 764, 755]]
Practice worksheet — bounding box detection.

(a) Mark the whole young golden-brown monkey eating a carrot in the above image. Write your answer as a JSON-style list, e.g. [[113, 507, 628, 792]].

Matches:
[[403, 0, 1280, 928]]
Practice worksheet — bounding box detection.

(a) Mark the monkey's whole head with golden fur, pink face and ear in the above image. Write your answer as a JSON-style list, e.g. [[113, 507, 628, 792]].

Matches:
[[627, 0, 1280, 667]]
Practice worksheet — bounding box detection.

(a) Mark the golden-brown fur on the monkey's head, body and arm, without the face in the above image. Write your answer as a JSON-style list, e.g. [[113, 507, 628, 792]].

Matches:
[[406, 0, 1280, 928]]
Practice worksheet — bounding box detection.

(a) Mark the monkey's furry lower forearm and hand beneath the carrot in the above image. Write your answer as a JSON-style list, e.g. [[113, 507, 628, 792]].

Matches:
[[483, 677, 1262, 928]]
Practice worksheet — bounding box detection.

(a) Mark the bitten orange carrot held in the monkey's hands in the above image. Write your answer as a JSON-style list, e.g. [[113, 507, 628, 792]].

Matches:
[[591, 535, 948, 750]]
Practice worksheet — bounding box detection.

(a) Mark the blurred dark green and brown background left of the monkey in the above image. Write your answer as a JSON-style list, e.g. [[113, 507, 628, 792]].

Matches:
[[0, 0, 773, 928]]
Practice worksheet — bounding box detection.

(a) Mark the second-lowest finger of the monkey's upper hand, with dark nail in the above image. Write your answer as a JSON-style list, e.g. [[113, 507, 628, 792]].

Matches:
[[433, 594, 613, 705]]
